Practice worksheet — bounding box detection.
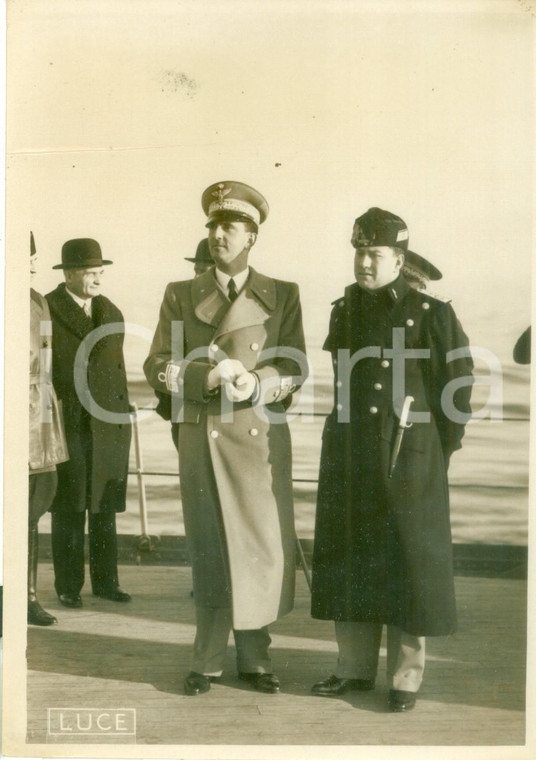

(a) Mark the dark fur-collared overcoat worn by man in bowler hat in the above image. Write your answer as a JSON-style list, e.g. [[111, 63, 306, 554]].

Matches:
[[46, 283, 131, 513]]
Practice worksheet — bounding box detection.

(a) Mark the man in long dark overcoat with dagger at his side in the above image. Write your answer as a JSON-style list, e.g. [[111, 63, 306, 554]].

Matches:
[[312, 208, 472, 712]]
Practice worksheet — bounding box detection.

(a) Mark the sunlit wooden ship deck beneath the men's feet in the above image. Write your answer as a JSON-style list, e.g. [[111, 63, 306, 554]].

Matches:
[[28, 563, 526, 757]]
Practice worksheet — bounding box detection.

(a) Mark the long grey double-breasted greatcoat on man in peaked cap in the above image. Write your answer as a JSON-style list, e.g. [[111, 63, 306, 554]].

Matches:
[[144, 268, 307, 630]]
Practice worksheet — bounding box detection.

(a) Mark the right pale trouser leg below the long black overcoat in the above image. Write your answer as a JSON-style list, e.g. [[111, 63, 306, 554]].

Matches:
[[387, 626, 425, 692]]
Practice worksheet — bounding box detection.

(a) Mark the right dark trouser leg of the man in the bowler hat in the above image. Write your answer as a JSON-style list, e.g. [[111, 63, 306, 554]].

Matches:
[[88, 512, 119, 594]]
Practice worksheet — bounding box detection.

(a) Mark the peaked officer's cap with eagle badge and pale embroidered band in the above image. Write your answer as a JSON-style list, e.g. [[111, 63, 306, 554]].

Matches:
[[201, 180, 269, 226]]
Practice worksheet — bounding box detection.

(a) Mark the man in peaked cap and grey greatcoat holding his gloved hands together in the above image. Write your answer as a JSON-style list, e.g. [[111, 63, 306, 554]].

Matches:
[[144, 181, 307, 695]]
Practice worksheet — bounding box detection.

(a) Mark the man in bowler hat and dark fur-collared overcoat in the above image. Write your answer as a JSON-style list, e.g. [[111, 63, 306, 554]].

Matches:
[[46, 238, 131, 607]]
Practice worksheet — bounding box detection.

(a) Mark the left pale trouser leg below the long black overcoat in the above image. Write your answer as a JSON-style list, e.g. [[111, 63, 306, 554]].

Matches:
[[335, 622, 382, 681]]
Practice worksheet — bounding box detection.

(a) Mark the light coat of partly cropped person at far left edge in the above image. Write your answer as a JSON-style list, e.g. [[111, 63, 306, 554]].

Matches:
[[29, 288, 69, 475]]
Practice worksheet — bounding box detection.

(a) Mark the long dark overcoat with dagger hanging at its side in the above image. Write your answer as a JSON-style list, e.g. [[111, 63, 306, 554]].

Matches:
[[312, 275, 473, 636]]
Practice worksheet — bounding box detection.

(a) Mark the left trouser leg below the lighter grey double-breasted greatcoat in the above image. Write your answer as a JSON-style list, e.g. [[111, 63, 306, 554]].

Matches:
[[190, 607, 233, 676]]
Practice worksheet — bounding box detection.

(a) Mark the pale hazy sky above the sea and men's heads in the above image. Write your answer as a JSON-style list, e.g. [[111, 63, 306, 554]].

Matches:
[[7, 0, 534, 386]]
